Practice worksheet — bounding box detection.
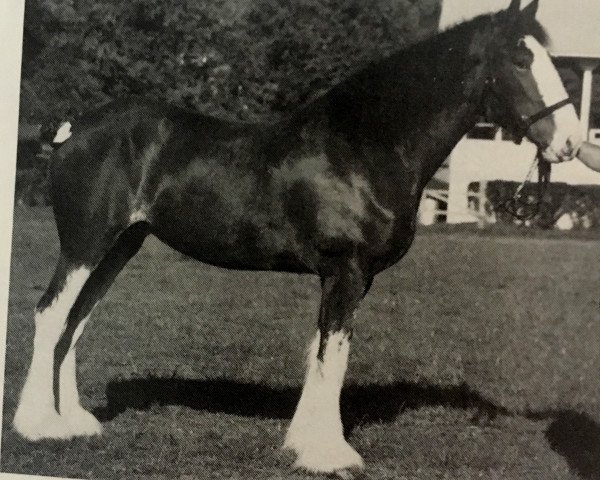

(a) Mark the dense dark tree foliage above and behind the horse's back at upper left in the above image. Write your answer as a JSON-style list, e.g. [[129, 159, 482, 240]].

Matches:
[[21, 0, 439, 123]]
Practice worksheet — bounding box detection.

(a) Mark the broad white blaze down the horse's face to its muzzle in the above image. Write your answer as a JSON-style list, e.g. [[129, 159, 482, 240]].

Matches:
[[523, 35, 582, 162]]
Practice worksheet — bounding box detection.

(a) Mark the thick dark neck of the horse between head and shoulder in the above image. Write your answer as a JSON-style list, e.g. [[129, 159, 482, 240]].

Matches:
[[290, 26, 484, 183]]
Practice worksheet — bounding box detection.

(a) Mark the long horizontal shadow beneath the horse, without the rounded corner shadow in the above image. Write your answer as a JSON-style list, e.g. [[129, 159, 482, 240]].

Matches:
[[94, 377, 508, 433]]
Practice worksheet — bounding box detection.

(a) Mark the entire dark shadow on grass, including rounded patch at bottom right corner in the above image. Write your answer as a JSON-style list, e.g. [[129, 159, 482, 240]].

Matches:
[[94, 377, 600, 480]]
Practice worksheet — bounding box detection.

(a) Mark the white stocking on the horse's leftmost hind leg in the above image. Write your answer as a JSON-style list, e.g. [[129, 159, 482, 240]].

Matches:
[[13, 268, 98, 440]]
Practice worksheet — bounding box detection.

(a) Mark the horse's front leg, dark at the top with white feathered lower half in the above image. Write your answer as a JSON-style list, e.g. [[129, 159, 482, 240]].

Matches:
[[284, 259, 370, 473]]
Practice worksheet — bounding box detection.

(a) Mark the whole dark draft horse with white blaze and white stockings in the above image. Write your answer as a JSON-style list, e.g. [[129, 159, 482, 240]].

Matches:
[[14, 0, 581, 474]]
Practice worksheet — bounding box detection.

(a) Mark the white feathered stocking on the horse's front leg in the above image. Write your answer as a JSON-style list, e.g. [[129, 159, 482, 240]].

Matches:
[[283, 332, 364, 473]]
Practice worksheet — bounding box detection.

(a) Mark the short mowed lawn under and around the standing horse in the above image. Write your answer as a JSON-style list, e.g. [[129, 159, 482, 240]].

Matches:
[[1, 208, 600, 480]]
